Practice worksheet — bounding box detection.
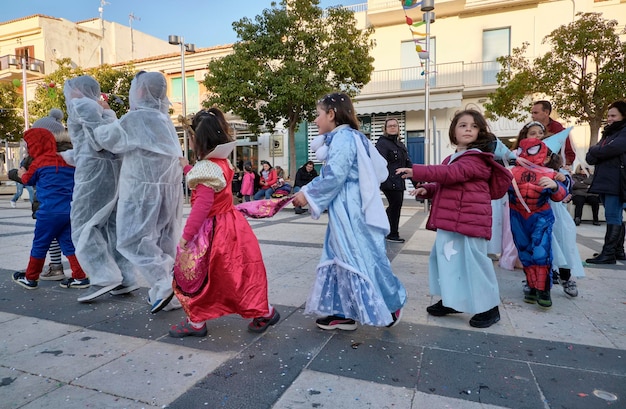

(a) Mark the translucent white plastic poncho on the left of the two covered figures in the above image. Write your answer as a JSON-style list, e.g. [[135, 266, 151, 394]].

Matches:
[[63, 75, 135, 286]]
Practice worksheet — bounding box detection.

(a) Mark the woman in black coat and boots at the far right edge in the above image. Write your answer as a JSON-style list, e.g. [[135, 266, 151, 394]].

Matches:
[[587, 101, 626, 264]]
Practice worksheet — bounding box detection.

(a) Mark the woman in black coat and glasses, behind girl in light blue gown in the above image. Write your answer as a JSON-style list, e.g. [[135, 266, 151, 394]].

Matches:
[[376, 118, 413, 243]]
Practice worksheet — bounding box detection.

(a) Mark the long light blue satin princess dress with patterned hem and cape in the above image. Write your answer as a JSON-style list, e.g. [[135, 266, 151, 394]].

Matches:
[[301, 127, 406, 326]]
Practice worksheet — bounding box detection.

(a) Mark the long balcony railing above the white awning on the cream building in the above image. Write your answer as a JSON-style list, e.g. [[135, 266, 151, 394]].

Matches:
[[360, 61, 500, 97]]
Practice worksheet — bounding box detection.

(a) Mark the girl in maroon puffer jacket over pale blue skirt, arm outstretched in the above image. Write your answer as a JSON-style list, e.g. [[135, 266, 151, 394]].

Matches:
[[396, 110, 512, 328]]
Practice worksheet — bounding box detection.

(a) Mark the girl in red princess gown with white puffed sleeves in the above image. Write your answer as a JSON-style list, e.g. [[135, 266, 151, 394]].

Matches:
[[169, 108, 280, 338]]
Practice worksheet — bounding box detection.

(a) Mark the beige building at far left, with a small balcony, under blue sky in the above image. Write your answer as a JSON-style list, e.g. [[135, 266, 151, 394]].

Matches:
[[0, 14, 177, 172]]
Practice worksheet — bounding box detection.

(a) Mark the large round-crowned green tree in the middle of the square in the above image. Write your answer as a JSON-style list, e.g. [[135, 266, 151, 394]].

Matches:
[[204, 0, 374, 175]]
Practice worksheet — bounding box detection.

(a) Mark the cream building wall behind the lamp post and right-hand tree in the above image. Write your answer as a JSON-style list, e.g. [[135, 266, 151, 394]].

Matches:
[[351, 0, 626, 163]]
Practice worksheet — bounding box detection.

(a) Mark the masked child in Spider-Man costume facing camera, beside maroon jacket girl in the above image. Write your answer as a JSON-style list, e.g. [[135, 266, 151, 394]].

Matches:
[[509, 138, 567, 309]]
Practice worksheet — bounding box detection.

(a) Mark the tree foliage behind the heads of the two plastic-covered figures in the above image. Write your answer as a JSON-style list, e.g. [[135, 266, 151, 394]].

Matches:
[[28, 58, 135, 122]]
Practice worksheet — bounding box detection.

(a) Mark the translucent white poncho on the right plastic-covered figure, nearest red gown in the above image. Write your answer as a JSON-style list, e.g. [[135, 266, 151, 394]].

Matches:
[[94, 72, 183, 301]]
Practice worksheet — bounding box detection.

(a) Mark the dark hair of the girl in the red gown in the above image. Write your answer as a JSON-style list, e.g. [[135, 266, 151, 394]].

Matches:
[[191, 108, 234, 159]]
